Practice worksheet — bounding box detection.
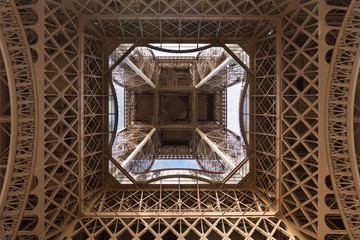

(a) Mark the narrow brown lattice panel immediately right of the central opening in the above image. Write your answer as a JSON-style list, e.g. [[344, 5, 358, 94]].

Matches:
[[251, 35, 276, 199]]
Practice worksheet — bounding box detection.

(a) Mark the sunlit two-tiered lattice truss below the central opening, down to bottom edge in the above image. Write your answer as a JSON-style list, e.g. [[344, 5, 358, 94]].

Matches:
[[73, 187, 290, 239]]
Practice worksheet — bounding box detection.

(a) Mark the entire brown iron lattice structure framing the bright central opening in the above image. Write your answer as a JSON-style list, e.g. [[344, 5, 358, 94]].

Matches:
[[0, 0, 360, 239]]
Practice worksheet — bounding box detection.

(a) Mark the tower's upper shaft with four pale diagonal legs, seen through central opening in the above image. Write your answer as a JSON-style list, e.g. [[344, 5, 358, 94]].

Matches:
[[107, 44, 248, 184]]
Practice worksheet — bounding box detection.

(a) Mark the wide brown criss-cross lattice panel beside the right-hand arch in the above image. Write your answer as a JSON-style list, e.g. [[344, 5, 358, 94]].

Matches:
[[281, 1, 319, 239]]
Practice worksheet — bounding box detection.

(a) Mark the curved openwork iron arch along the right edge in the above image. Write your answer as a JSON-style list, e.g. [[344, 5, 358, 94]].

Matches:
[[325, 0, 360, 239]]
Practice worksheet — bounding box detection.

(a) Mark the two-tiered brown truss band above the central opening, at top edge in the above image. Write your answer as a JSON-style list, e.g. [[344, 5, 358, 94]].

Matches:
[[74, 0, 287, 42]]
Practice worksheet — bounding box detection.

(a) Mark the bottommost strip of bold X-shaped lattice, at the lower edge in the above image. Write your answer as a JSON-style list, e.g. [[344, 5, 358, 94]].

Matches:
[[73, 217, 290, 240]]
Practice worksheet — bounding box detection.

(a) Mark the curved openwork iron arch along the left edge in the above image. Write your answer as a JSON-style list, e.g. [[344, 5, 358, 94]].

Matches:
[[0, 0, 36, 239]]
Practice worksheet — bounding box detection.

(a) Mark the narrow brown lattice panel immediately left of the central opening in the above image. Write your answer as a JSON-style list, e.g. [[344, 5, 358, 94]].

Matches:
[[83, 27, 105, 202]]
